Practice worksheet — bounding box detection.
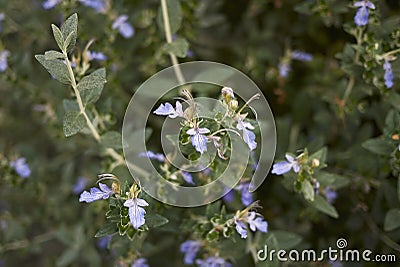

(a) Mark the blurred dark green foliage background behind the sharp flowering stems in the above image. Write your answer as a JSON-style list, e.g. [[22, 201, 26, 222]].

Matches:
[[0, 0, 400, 266]]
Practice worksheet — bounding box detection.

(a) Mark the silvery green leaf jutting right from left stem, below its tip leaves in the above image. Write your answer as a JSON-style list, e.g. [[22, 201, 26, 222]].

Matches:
[[78, 68, 107, 106]]
